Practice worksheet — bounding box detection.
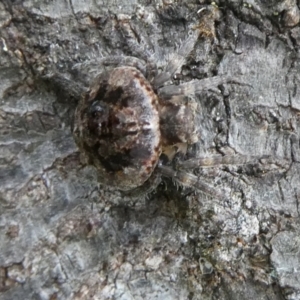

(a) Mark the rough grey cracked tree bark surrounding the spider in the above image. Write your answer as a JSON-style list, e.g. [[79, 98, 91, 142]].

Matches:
[[0, 0, 300, 299]]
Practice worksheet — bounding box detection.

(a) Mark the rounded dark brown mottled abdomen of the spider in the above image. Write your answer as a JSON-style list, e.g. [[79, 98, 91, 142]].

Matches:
[[74, 67, 161, 190]]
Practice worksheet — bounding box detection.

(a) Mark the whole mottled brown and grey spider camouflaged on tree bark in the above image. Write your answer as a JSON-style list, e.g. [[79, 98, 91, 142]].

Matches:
[[73, 18, 251, 197]]
